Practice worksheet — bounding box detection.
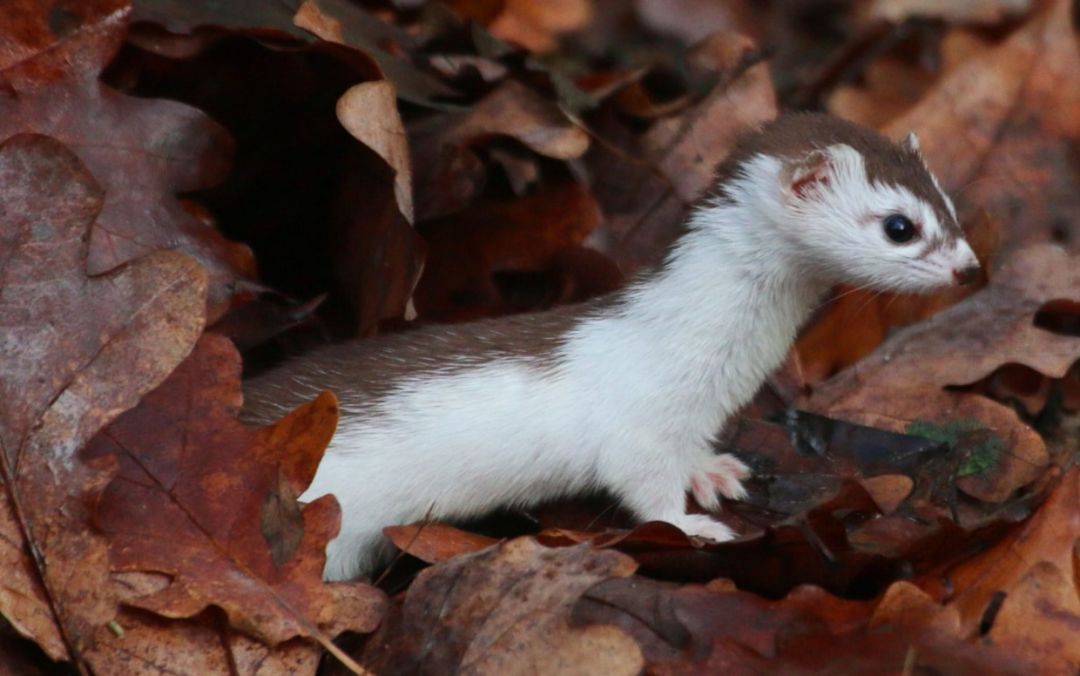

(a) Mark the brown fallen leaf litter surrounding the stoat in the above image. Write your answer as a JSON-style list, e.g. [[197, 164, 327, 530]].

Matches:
[[0, 0, 1080, 674]]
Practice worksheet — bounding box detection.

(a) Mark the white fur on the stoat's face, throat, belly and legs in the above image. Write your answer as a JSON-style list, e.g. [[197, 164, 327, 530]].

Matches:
[[302, 146, 973, 579]]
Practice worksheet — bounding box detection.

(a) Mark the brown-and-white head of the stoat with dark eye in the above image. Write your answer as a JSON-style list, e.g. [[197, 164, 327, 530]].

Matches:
[[721, 114, 978, 292]]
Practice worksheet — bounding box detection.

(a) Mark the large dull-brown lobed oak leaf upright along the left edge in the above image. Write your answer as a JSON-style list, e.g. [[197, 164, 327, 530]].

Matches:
[[0, 134, 206, 659]]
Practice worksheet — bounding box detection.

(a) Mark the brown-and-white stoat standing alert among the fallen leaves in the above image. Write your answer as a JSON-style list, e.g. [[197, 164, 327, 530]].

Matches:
[[245, 113, 978, 579]]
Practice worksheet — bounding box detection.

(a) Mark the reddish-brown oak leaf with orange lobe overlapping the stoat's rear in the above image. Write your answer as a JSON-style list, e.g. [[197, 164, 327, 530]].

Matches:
[[84, 334, 383, 651]]
